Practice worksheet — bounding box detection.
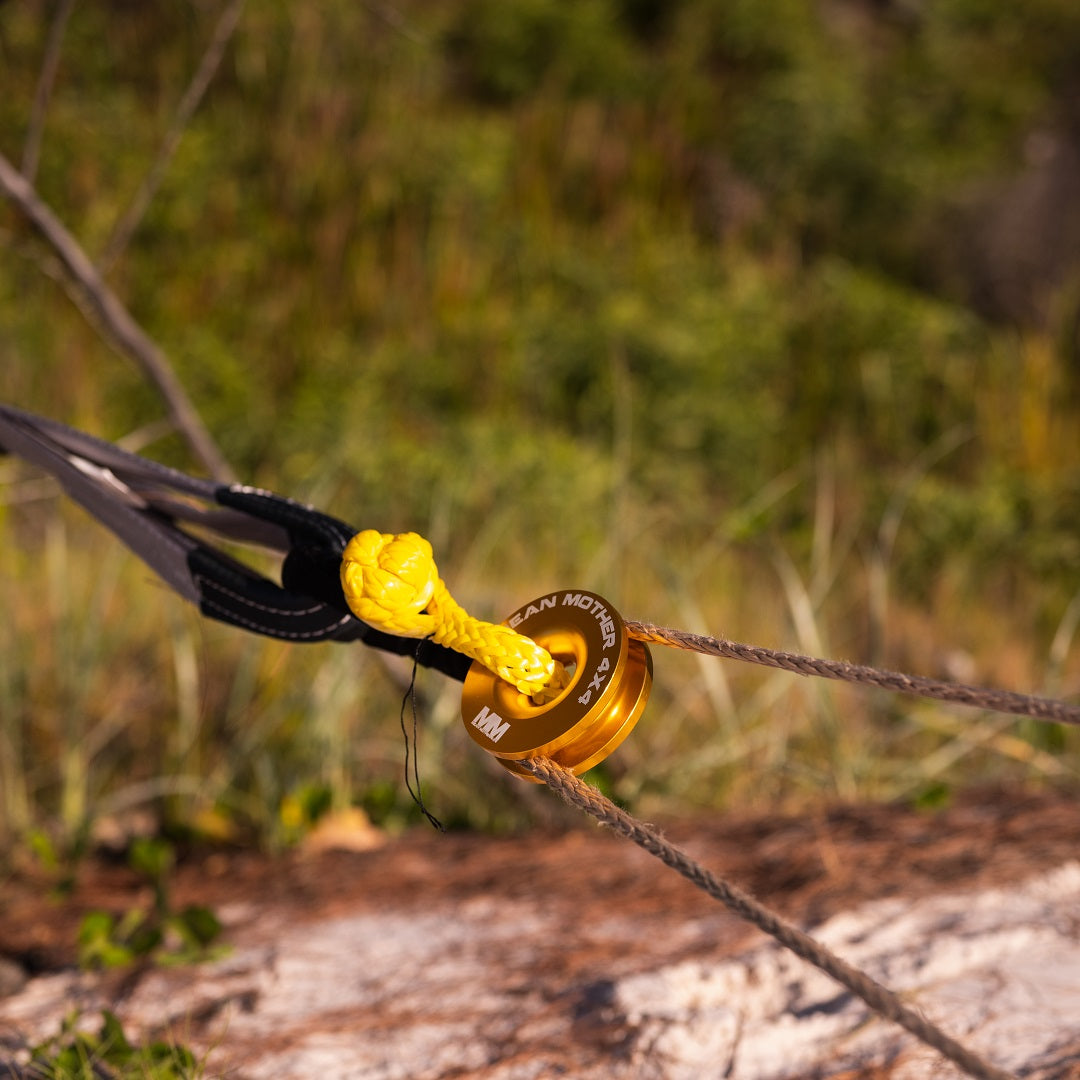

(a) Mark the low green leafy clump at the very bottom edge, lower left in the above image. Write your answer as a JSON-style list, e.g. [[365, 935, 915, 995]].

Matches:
[[27, 1010, 203, 1080]]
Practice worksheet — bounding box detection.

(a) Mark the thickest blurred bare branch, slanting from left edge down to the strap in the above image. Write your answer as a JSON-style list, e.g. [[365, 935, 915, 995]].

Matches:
[[0, 153, 233, 482]]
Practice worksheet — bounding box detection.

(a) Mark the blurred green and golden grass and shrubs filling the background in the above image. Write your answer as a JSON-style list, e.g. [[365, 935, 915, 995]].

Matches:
[[0, 0, 1080, 848]]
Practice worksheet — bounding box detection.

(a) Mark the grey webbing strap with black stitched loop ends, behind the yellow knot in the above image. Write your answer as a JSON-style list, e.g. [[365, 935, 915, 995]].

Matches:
[[0, 404, 470, 680]]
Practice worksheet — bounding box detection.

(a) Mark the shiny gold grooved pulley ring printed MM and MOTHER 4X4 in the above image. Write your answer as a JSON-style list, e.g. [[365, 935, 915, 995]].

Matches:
[[461, 590, 652, 780]]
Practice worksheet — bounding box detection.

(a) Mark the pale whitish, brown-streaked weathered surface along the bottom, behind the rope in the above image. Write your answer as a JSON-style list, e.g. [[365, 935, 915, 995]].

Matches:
[[0, 862, 1080, 1080]]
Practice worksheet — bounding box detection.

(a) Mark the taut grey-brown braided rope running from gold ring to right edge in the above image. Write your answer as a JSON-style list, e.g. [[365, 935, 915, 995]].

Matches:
[[626, 621, 1080, 725]]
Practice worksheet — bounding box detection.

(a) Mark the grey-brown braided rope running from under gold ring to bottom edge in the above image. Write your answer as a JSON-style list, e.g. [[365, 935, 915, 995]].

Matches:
[[521, 757, 1015, 1080]]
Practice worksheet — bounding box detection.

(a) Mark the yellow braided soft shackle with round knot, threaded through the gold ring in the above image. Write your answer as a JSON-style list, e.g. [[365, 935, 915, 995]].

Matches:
[[341, 529, 569, 704]]
